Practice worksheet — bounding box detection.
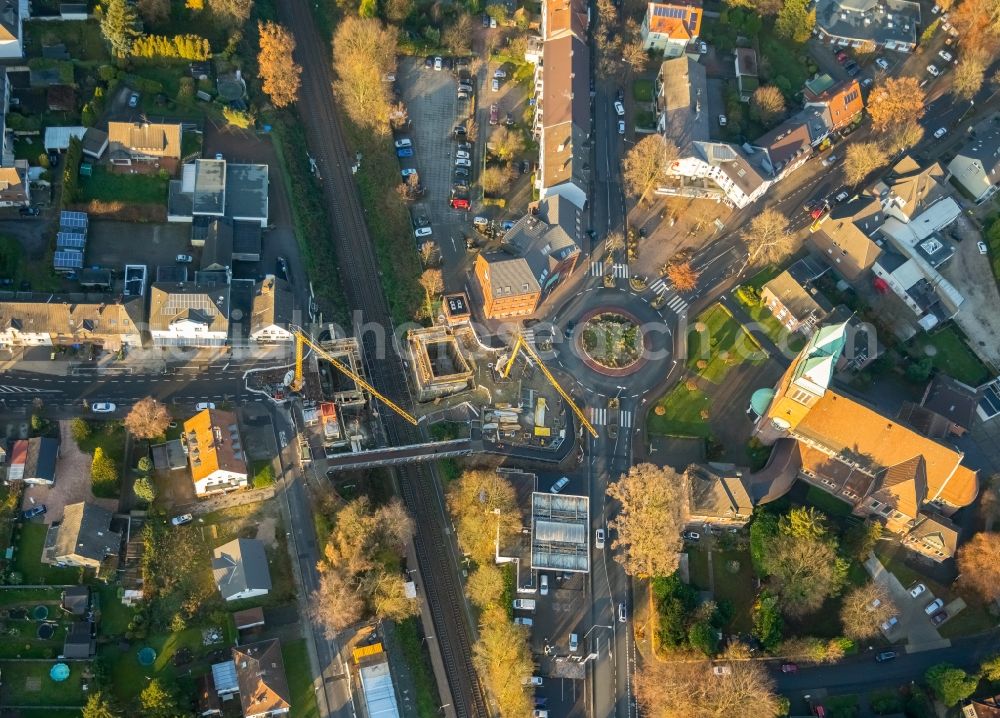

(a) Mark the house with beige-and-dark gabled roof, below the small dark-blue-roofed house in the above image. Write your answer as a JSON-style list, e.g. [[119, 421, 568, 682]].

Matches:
[[42, 502, 122, 570]]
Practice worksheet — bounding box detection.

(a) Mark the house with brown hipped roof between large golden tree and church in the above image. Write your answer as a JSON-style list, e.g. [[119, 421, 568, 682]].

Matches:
[[686, 463, 754, 528]]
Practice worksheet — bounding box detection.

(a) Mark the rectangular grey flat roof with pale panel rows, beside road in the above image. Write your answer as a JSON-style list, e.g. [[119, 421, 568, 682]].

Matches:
[[531, 491, 590, 573]]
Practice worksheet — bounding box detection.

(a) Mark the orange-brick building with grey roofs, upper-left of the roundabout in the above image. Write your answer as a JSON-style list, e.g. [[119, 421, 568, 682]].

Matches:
[[475, 195, 584, 319]]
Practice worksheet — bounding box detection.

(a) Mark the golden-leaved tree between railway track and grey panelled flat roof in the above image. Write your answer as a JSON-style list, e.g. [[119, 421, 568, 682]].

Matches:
[[447, 469, 521, 563]]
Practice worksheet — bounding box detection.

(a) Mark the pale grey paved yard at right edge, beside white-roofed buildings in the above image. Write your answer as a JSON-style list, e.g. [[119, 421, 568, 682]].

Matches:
[[941, 215, 1000, 366]]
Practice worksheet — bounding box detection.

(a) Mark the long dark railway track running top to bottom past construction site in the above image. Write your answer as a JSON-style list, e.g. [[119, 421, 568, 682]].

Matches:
[[279, 0, 489, 718]]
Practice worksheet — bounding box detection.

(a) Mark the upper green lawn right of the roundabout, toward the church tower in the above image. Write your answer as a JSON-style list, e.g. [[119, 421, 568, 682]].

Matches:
[[688, 303, 767, 384]]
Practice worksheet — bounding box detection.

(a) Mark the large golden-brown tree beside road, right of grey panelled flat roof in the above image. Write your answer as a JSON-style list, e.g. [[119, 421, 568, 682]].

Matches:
[[607, 464, 689, 576]]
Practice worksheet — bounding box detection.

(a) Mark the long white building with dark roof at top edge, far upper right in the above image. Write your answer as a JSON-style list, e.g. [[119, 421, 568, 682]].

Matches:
[[816, 0, 920, 52]]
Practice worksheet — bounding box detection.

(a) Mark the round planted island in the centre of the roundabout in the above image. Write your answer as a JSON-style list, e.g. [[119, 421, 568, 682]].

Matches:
[[578, 309, 645, 376]]
